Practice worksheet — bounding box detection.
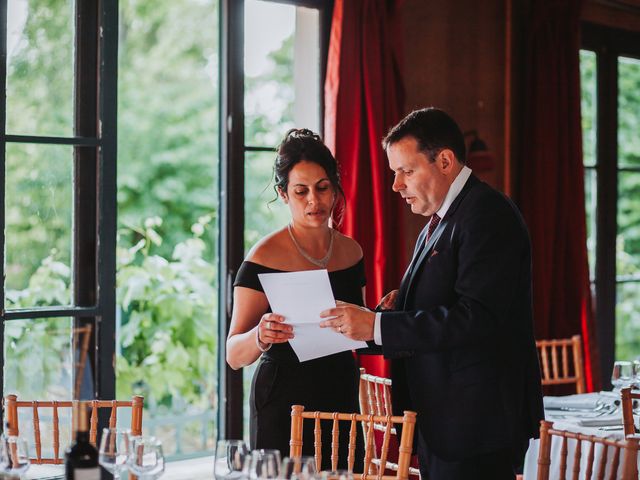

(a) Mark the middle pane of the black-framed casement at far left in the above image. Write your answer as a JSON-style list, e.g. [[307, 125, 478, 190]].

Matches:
[[5, 143, 73, 308]]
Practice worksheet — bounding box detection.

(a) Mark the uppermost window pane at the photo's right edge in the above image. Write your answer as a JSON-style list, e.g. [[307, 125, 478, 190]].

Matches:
[[618, 57, 640, 167]]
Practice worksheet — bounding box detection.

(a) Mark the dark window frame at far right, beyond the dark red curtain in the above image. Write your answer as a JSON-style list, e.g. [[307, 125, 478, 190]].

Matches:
[[581, 22, 640, 387]]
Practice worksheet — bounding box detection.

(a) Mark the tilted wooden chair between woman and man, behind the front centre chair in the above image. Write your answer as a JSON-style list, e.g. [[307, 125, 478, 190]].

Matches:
[[359, 368, 420, 477]]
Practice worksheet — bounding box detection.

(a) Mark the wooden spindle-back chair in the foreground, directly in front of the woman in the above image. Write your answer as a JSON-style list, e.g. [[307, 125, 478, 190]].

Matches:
[[289, 405, 416, 480]]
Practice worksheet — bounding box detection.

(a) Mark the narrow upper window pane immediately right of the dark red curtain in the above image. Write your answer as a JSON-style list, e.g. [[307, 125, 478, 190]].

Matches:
[[580, 50, 598, 166]]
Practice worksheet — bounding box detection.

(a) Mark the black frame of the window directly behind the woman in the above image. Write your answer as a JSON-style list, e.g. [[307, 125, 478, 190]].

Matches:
[[218, 0, 333, 438]]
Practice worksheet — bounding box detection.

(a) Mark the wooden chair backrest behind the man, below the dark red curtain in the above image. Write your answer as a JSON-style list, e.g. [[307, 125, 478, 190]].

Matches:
[[536, 335, 585, 393]]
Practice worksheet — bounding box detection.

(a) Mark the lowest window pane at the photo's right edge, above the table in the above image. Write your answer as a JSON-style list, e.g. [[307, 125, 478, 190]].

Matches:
[[616, 282, 640, 360]]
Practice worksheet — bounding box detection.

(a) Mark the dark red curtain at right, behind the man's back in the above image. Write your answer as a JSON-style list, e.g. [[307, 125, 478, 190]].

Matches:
[[520, 0, 600, 390]]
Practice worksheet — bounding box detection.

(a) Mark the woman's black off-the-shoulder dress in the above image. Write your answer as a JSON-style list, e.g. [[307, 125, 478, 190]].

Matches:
[[234, 259, 365, 470]]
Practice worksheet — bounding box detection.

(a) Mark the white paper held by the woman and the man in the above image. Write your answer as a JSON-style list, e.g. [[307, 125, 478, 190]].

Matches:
[[258, 270, 367, 362]]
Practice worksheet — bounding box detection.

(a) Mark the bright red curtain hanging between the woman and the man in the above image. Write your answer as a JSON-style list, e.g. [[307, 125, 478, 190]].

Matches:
[[325, 0, 406, 376]]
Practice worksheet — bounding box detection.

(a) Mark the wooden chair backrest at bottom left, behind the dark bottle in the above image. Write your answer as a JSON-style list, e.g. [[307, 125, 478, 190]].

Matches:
[[5, 394, 144, 465]]
